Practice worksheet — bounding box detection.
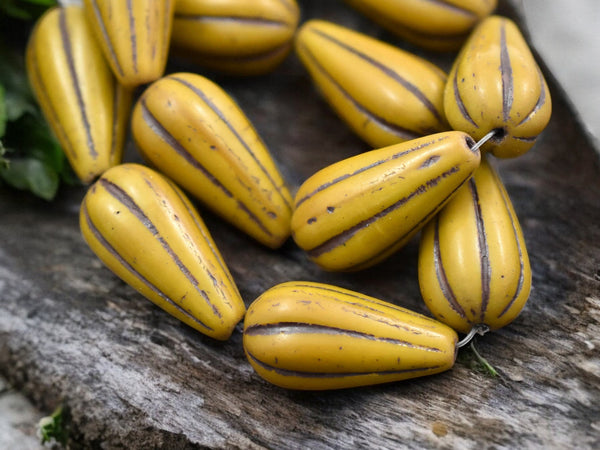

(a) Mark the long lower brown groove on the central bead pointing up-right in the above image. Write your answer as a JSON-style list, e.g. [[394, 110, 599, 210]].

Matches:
[[307, 166, 459, 258]]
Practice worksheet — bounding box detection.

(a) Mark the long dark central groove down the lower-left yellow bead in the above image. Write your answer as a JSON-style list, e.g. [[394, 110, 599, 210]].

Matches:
[[98, 178, 222, 318]]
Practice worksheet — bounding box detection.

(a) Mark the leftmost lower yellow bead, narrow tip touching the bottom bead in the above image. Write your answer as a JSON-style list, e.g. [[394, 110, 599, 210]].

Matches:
[[80, 164, 246, 340]]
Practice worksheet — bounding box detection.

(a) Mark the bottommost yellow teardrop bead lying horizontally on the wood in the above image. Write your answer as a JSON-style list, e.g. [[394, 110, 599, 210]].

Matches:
[[243, 281, 457, 390]]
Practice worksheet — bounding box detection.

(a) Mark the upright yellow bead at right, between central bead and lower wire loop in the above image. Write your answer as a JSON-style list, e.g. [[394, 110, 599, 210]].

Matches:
[[419, 158, 531, 333]]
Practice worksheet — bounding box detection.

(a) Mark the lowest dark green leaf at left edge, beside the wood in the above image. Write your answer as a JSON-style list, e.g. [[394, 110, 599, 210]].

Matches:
[[0, 158, 60, 200]]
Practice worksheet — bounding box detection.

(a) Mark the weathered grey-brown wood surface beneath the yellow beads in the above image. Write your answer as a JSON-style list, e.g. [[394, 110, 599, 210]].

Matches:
[[0, 1, 600, 449]]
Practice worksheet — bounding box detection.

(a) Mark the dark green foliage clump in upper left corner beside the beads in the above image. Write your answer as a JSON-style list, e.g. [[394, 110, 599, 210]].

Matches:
[[0, 4, 71, 200]]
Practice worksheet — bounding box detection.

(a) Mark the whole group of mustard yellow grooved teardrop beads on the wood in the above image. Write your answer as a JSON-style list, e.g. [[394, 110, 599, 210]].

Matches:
[[28, 0, 551, 389]]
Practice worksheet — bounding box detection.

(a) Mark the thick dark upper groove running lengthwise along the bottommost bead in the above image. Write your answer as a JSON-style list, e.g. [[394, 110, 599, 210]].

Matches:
[[244, 322, 442, 353]]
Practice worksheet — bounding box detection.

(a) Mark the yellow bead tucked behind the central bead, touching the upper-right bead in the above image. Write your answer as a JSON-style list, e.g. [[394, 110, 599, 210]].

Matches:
[[295, 20, 449, 148]]
